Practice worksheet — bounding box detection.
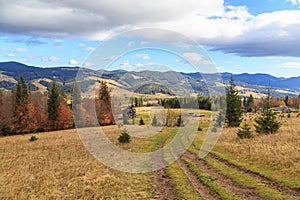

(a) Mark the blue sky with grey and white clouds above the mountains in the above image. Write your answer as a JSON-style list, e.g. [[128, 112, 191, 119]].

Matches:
[[0, 0, 300, 77]]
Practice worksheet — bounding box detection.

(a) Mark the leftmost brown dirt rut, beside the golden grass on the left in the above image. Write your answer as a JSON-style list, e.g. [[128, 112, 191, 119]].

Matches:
[[153, 139, 178, 200]]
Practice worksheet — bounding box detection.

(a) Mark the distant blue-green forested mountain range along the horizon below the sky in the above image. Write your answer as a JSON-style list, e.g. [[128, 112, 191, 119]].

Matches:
[[0, 62, 300, 96]]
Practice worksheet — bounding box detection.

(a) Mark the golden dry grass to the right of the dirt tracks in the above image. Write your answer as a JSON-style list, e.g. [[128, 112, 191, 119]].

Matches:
[[194, 113, 300, 188]]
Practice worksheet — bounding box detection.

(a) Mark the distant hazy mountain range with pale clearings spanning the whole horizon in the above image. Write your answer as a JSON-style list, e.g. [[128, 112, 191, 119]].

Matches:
[[0, 62, 300, 96]]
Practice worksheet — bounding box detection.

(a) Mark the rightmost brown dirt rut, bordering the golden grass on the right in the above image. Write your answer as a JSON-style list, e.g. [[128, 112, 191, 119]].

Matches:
[[208, 152, 300, 199]]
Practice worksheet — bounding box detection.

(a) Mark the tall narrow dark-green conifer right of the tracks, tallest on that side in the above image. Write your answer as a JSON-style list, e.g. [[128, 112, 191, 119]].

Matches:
[[226, 77, 242, 127]]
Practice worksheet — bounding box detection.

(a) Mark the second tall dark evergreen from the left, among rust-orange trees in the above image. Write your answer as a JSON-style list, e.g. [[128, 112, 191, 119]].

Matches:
[[47, 81, 59, 121]]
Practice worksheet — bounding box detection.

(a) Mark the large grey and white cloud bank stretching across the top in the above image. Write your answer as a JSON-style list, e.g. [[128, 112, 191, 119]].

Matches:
[[0, 0, 300, 56]]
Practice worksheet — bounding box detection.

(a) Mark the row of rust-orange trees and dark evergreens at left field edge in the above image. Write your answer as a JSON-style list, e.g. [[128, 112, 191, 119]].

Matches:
[[0, 76, 114, 136]]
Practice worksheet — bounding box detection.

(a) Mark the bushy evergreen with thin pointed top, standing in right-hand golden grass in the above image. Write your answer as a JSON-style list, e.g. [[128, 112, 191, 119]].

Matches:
[[254, 85, 280, 134]]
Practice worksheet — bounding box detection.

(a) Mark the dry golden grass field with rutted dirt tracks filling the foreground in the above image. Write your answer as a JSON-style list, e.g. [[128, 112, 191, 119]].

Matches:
[[0, 110, 300, 199]]
